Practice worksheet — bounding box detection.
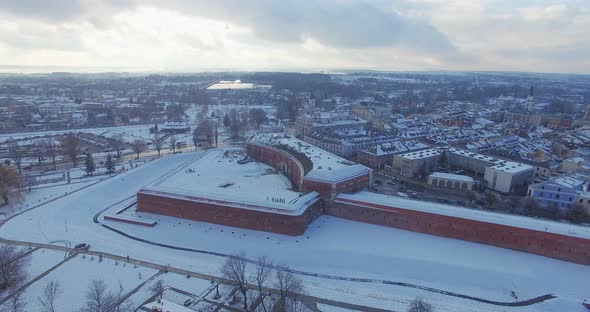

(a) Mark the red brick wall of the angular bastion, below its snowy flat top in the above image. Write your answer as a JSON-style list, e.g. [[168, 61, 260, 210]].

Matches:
[[137, 191, 322, 236]]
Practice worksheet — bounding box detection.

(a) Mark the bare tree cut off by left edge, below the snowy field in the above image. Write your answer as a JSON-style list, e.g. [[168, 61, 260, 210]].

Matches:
[[0, 244, 31, 293]]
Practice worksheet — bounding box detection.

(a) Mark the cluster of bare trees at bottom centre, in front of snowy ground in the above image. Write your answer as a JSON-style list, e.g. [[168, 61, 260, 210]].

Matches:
[[221, 253, 304, 312]]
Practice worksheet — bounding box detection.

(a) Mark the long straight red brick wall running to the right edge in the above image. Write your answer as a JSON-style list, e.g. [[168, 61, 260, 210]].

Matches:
[[325, 199, 590, 265]]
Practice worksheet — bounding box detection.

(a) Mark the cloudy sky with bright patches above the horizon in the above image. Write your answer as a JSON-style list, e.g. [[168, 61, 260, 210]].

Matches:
[[0, 0, 590, 73]]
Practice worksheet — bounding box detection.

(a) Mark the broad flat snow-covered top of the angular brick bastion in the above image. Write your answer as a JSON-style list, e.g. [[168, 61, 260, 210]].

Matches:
[[140, 149, 319, 215]]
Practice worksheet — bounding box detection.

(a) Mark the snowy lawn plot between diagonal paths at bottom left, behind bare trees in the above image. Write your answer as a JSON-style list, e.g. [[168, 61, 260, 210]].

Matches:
[[13, 255, 157, 311]]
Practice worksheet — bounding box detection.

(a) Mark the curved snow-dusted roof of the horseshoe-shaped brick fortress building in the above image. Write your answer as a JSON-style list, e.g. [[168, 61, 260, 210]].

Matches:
[[250, 133, 370, 182]]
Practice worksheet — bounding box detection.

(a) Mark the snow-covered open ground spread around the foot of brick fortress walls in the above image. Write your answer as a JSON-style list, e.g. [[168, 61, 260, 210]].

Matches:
[[0, 153, 590, 312]]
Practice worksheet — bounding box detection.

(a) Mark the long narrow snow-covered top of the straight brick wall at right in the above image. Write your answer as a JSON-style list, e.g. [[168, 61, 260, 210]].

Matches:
[[336, 191, 590, 239]]
